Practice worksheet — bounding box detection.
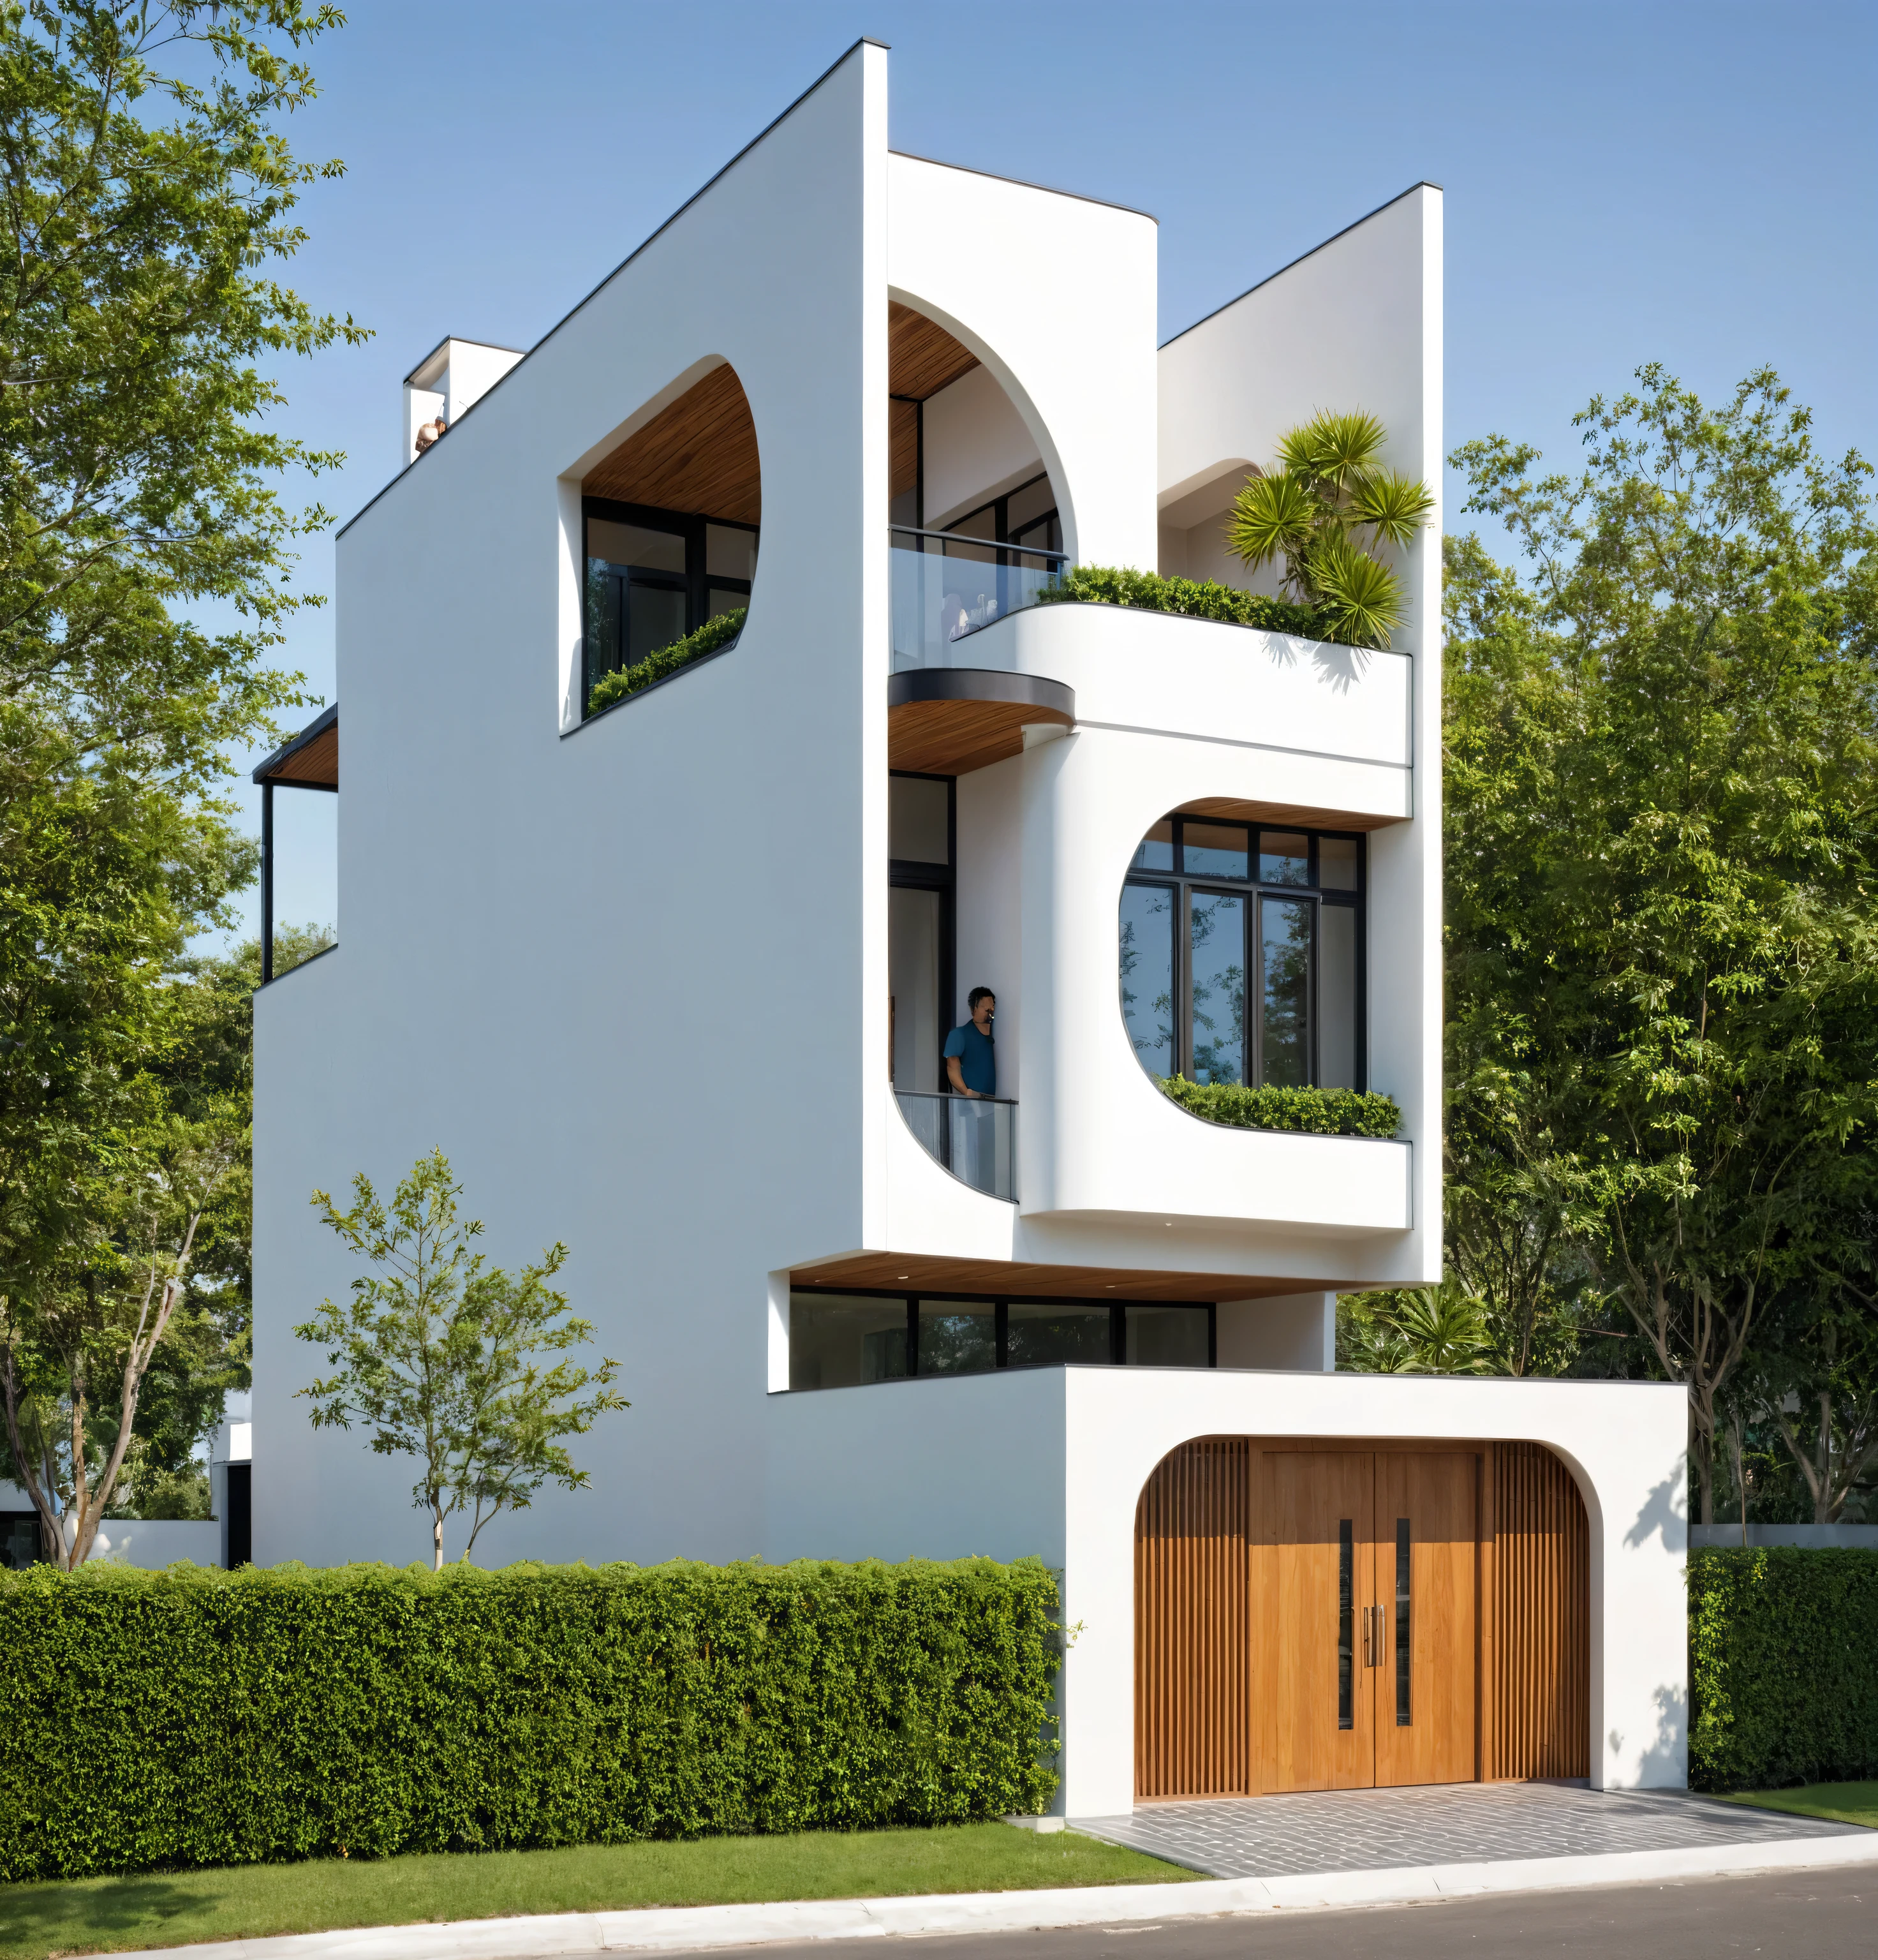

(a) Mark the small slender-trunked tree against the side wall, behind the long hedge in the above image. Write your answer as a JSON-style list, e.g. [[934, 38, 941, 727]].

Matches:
[[294, 1150, 629, 1572]]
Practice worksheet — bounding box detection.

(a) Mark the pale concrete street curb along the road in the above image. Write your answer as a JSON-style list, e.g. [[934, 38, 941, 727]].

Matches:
[[136, 1823, 1878, 1960]]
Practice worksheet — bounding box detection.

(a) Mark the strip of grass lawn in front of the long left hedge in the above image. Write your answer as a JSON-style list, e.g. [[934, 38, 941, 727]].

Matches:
[[0, 1823, 1196, 1960]]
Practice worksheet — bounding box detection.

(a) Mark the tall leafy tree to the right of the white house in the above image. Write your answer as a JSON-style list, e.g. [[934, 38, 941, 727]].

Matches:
[[1447, 366, 1878, 1521]]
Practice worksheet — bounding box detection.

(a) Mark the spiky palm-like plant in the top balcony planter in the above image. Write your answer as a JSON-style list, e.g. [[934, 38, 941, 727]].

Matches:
[[1227, 410, 1435, 647]]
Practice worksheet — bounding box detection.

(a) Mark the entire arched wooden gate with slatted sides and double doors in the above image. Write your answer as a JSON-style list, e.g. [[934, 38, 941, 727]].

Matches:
[[1135, 1437, 1590, 1797]]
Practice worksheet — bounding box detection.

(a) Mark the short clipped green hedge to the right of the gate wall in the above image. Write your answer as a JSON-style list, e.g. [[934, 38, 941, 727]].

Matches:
[[1690, 1547, 1878, 1790]]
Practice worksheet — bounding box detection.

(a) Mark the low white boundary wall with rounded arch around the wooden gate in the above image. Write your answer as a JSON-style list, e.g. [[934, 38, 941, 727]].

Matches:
[[764, 1372, 1688, 1817]]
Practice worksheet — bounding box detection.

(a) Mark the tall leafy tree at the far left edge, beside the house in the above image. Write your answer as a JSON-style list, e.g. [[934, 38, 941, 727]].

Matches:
[[0, 0, 360, 1562]]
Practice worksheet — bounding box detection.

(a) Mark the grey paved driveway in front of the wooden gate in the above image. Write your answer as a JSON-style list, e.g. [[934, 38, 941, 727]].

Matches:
[[1070, 1784, 1856, 1878]]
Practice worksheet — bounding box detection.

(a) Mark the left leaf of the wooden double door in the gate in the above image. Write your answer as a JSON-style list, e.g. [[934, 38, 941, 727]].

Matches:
[[1255, 1450, 1376, 1790]]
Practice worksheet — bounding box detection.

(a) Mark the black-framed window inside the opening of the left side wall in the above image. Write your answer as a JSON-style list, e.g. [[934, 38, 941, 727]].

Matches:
[[580, 498, 758, 713]]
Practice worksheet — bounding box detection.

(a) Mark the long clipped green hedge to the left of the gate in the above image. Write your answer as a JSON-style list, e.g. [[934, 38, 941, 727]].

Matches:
[[0, 1560, 1058, 1880]]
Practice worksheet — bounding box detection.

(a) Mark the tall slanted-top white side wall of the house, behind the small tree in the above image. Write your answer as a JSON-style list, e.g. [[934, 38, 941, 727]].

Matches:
[[255, 45, 890, 1564]]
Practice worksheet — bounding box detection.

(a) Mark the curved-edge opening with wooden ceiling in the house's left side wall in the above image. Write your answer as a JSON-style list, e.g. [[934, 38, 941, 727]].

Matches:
[[580, 364, 762, 713]]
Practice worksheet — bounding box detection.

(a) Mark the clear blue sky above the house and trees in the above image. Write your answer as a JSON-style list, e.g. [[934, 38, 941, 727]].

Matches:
[[243, 0, 1878, 948]]
